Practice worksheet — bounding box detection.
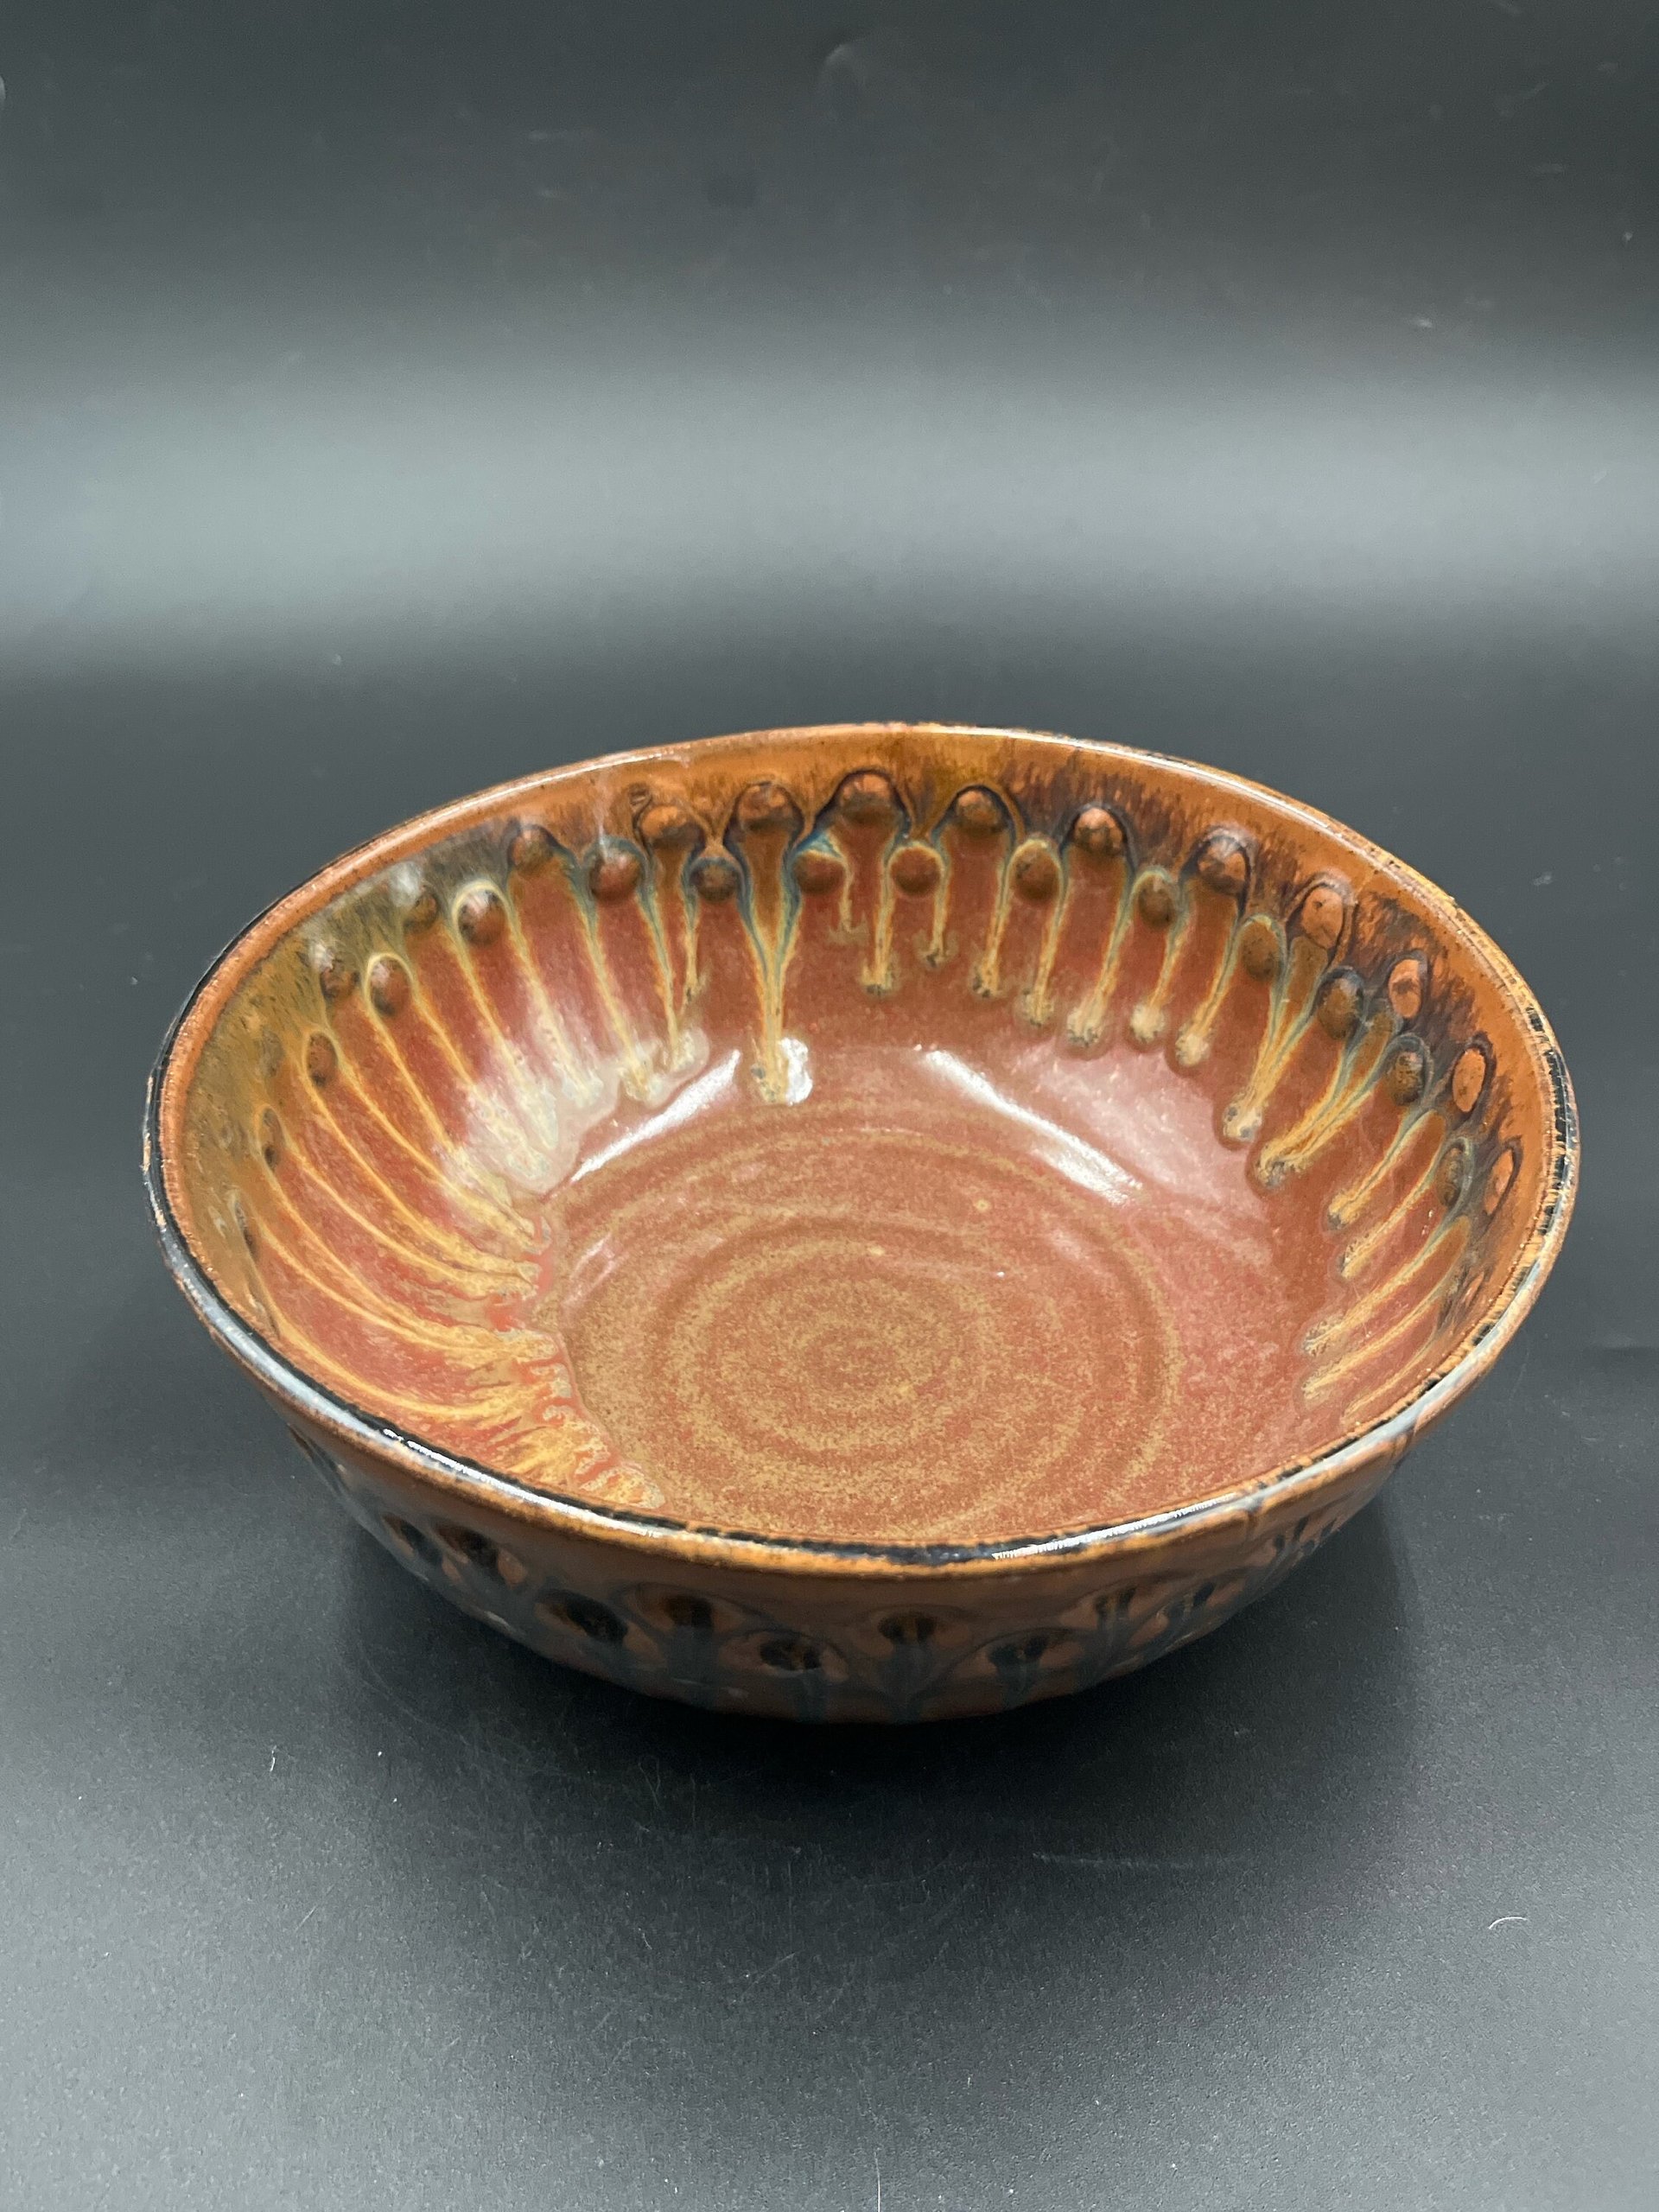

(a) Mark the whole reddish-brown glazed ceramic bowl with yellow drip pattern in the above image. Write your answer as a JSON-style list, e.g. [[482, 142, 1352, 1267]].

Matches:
[[146, 726, 1575, 1721]]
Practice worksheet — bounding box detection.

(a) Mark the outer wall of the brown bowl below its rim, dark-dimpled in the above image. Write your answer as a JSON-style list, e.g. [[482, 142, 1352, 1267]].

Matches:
[[279, 1405, 1405, 1723]]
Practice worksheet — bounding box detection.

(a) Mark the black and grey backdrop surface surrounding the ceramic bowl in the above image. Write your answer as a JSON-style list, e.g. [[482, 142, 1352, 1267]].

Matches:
[[0, 0, 1659, 2212]]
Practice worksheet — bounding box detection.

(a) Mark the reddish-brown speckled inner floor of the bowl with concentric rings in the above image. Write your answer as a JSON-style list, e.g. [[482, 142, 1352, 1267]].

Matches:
[[549, 1044, 1332, 1544]]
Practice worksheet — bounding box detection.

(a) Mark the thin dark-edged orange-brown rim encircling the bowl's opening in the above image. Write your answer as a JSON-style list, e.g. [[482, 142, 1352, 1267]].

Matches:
[[143, 721, 1580, 1577]]
